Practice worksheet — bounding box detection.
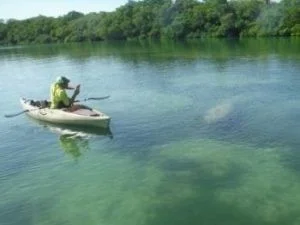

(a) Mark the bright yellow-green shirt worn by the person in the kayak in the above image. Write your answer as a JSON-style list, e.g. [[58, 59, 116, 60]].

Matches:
[[50, 83, 70, 109]]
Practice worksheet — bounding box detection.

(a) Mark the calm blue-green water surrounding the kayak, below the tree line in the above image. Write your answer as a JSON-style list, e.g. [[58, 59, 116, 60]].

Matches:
[[0, 39, 300, 225]]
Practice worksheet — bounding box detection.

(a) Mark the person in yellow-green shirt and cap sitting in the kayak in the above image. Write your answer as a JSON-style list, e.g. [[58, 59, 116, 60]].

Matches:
[[50, 77, 80, 111]]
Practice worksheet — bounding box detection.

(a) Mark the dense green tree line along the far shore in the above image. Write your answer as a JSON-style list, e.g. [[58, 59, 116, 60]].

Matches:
[[0, 0, 300, 45]]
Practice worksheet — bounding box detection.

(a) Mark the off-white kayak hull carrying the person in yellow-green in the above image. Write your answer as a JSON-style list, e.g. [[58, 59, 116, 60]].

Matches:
[[20, 98, 110, 128]]
